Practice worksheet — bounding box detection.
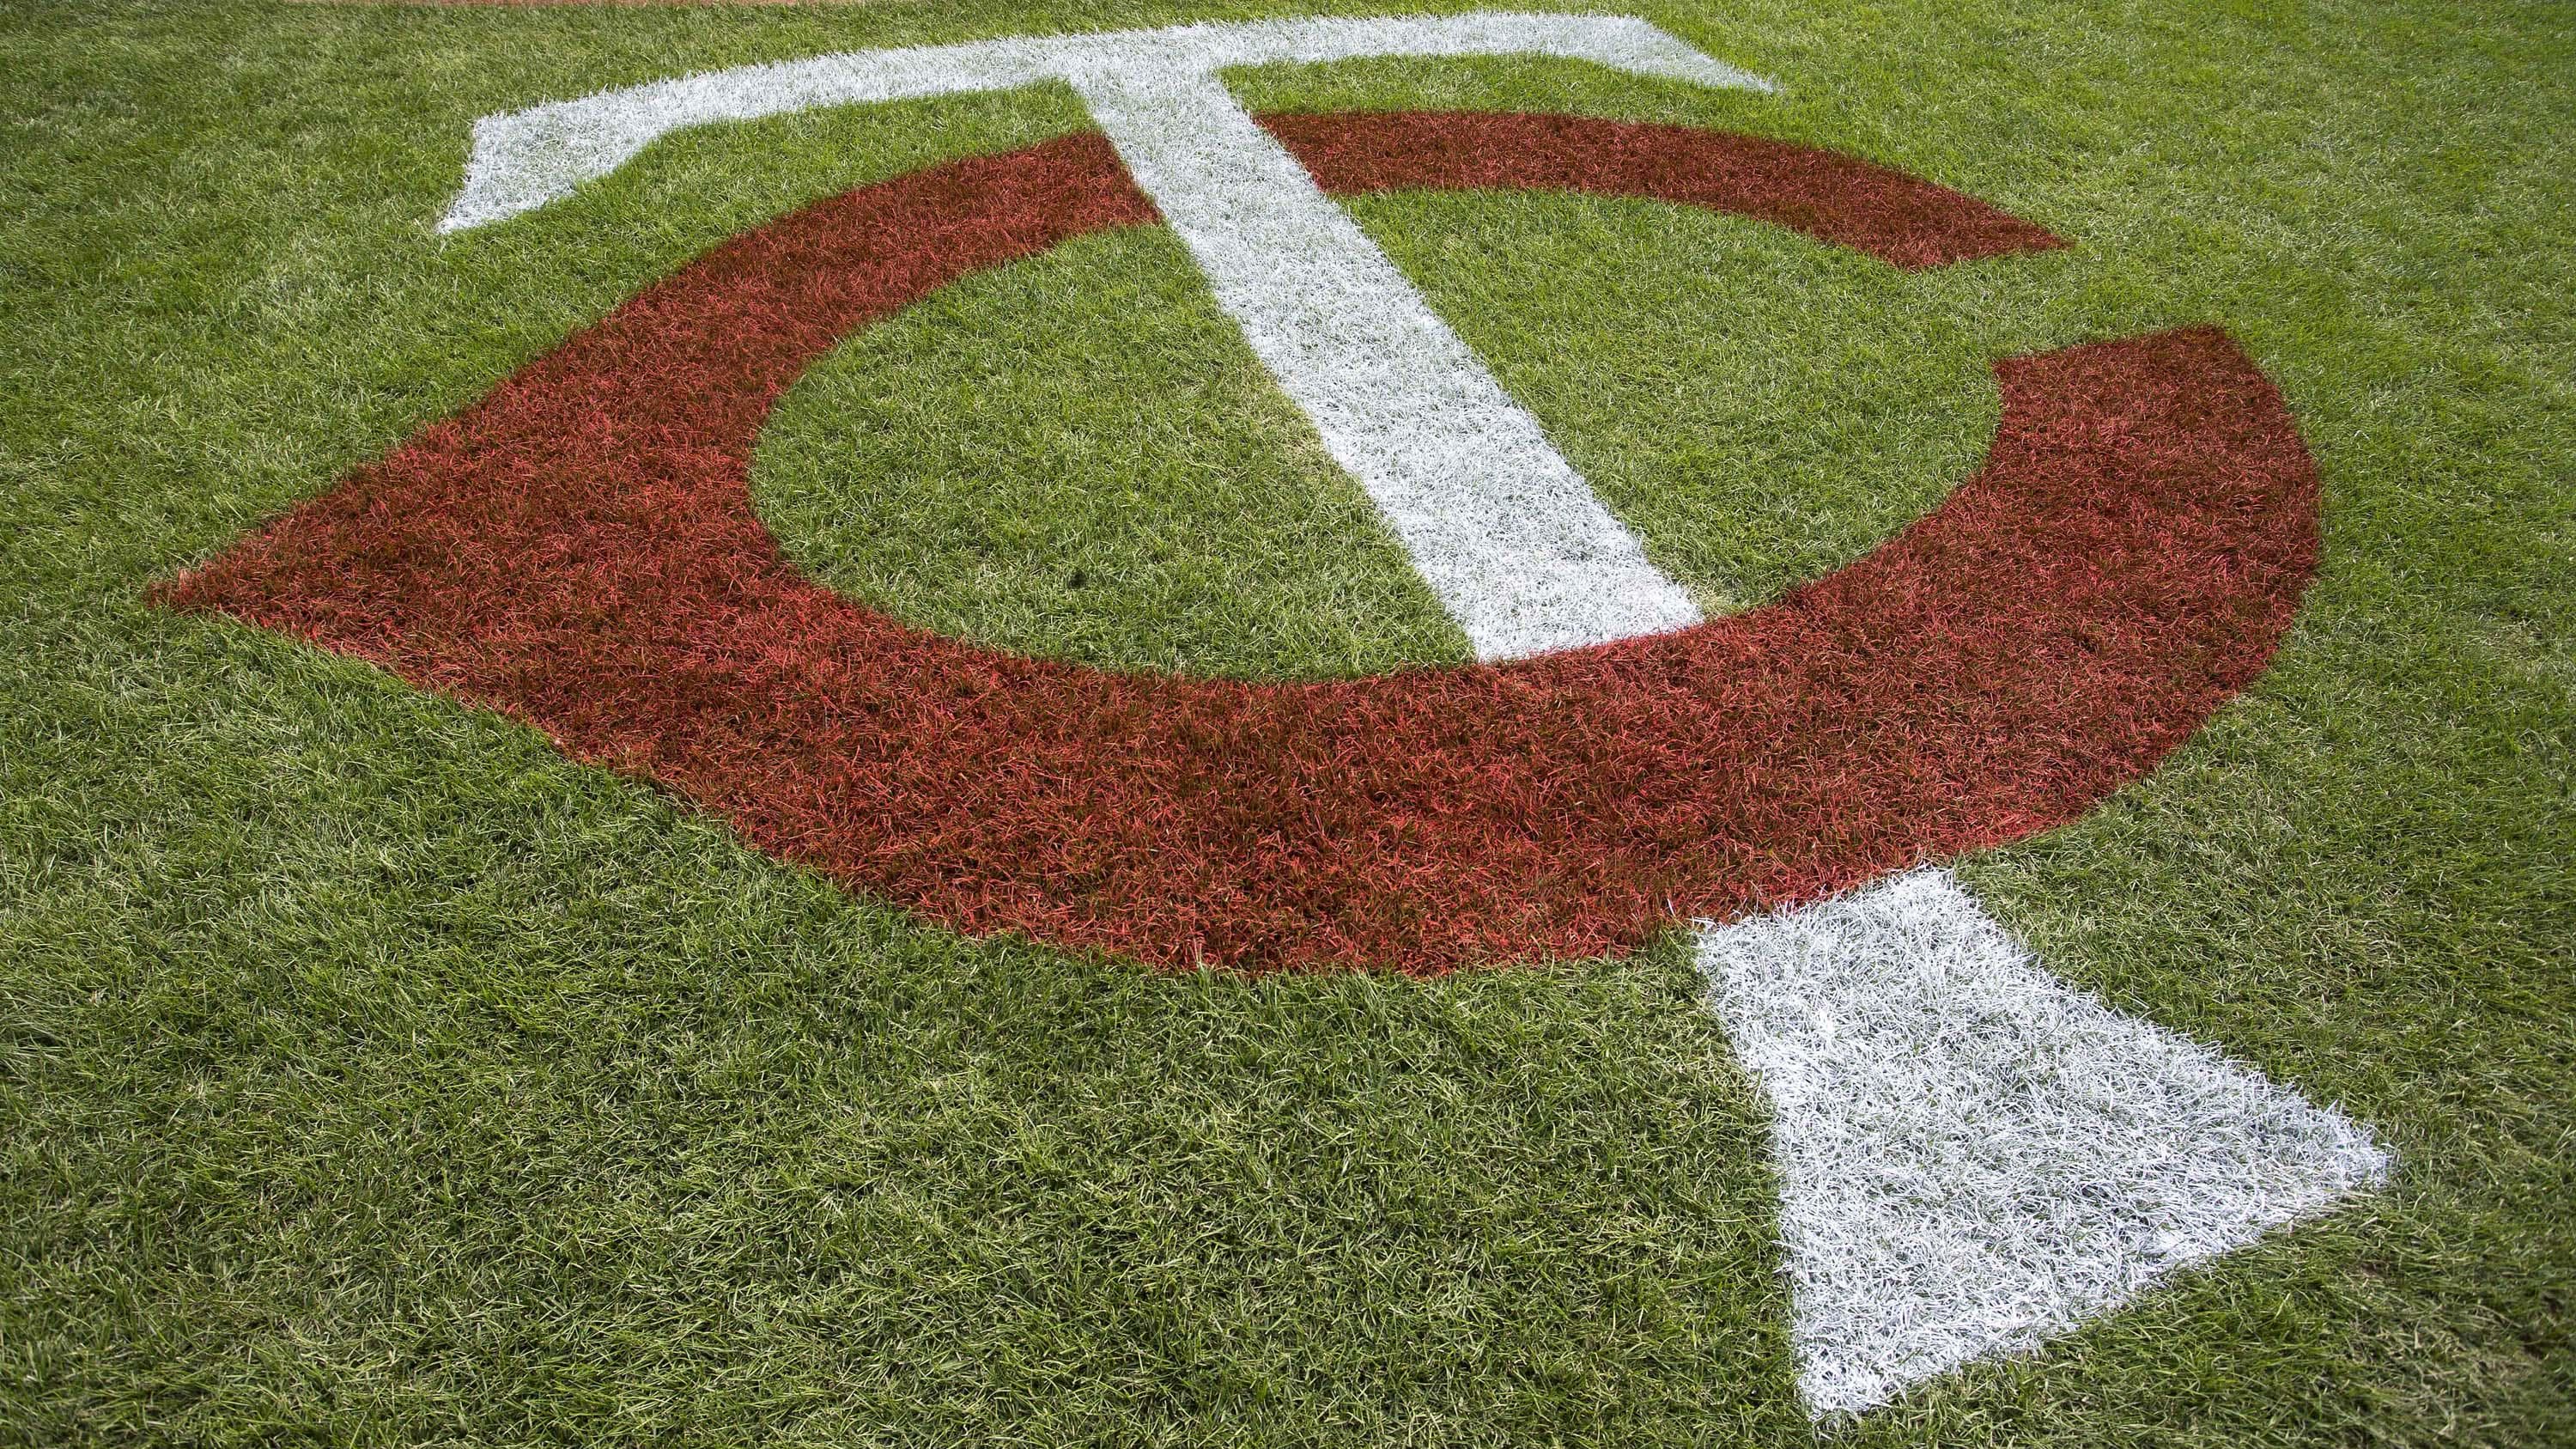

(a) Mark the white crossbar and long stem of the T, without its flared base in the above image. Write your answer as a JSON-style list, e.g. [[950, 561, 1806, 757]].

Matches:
[[440, 13, 1770, 660]]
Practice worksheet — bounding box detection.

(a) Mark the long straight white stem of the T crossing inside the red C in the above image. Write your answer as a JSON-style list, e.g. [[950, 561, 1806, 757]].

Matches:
[[1074, 70, 1700, 660]]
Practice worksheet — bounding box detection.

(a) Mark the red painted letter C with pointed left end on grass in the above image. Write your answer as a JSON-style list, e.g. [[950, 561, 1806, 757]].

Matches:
[[165, 116, 2316, 970]]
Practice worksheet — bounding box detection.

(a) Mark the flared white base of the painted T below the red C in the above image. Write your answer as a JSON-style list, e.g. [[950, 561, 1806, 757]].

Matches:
[[1698, 869, 2388, 1418]]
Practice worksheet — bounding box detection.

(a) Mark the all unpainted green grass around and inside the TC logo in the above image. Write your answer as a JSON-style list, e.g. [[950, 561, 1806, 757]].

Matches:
[[0, 0, 2576, 1449]]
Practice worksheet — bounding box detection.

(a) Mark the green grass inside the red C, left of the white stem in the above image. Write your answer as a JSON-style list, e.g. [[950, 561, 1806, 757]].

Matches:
[[752, 227, 1468, 678]]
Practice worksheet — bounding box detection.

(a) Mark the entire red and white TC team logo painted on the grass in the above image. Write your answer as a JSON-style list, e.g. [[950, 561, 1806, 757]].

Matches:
[[167, 15, 2378, 1408]]
